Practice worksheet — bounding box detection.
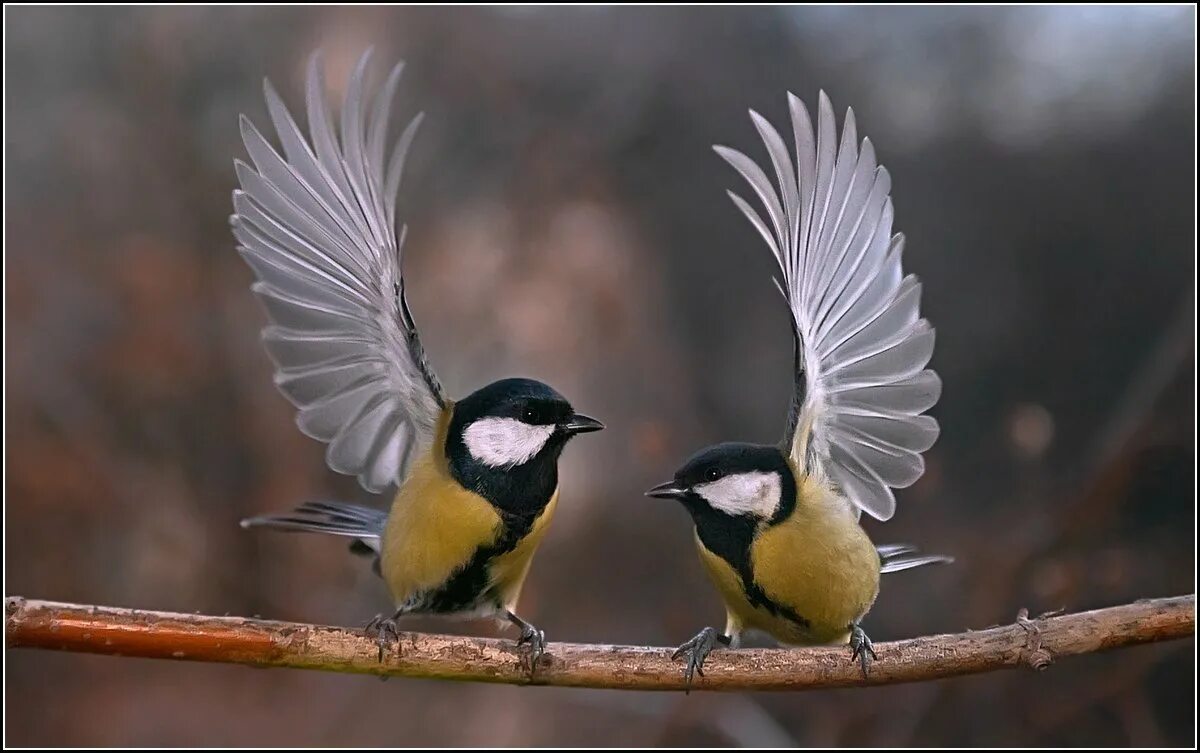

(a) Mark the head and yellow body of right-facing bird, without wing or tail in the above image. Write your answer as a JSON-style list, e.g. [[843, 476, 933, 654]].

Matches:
[[379, 380, 582, 616]]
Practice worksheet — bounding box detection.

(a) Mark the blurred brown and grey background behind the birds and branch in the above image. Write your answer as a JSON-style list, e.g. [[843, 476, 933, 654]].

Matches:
[[5, 7, 1195, 746]]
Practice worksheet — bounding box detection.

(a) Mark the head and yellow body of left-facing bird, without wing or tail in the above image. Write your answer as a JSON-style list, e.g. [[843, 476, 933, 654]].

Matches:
[[650, 442, 881, 645]]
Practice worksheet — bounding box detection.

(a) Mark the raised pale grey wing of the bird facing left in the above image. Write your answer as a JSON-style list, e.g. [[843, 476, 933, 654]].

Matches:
[[714, 92, 941, 520]]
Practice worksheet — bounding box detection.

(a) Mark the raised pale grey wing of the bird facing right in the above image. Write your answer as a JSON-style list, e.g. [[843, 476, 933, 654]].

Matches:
[[230, 52, 446, 492]]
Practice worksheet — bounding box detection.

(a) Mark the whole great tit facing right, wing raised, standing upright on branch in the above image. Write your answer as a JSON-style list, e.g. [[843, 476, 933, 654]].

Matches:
[[230, 50, 604, 669]]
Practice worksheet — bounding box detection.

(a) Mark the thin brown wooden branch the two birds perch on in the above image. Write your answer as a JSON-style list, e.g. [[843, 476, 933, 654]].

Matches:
[[5, 595, 1195, 691]]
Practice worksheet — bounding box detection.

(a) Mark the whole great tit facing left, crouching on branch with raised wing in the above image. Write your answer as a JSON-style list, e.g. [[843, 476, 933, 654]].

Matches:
[[647, 92, 950, 683]]
